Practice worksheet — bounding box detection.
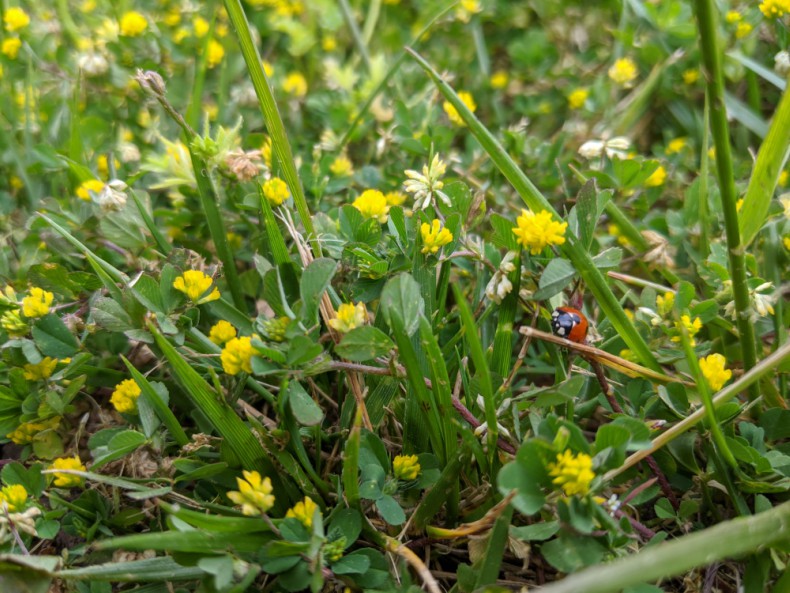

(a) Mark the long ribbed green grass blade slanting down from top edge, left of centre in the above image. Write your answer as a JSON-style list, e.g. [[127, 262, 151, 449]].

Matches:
[[225, 0, 321, 257]]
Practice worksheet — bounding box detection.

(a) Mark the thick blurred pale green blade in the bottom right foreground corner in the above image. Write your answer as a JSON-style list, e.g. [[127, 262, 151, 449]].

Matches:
[[541, 502, 790, 593]]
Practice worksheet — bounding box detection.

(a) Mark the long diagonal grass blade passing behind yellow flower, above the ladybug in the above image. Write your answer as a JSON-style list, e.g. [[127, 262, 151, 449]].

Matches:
[[409, 50, 660, 371]]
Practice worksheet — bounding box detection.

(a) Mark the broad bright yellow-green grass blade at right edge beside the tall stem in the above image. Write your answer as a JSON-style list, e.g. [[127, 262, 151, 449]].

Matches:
[[738, 83, 790, 249]]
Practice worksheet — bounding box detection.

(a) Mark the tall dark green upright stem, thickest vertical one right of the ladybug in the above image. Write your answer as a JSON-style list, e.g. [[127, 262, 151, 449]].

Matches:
[[694, 0, 760, 401]]
